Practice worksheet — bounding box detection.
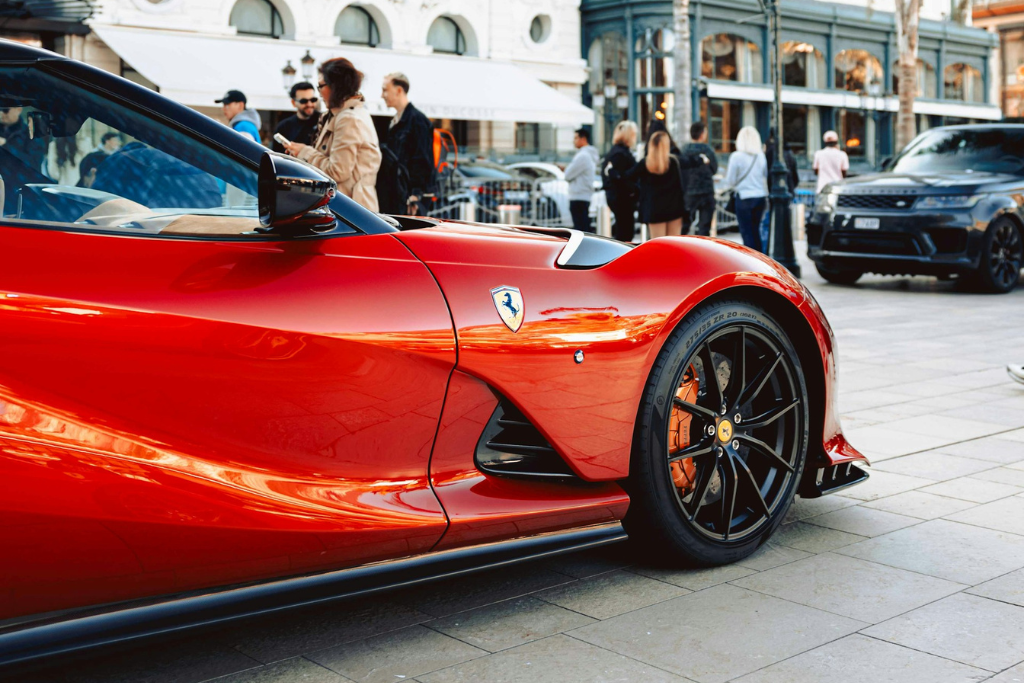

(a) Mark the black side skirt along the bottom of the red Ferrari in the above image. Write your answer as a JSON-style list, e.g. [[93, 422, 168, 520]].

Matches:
[[0, 522, 626, 667]]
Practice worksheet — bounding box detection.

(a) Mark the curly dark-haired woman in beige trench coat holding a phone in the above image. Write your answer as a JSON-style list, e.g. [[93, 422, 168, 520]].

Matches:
[[285, 57, 381, 211]]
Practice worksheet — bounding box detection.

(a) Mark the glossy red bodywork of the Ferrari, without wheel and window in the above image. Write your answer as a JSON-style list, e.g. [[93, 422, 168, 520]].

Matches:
[[0, 38, 864, 659]]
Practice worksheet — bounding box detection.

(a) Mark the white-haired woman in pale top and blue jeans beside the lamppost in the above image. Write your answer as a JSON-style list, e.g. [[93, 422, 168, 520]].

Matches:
[[725, 126, 768, 252]]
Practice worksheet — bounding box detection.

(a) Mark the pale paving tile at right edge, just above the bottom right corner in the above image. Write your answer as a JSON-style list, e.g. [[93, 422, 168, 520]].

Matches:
[[864, 593, 1024, 672]]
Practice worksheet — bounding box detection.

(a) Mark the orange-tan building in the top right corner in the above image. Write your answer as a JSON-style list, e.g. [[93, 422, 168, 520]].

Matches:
[[973, 0, 1024, 123]]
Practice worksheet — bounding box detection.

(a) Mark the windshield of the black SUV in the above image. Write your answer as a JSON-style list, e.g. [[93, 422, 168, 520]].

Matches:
[[892, 128, 1024, 173]]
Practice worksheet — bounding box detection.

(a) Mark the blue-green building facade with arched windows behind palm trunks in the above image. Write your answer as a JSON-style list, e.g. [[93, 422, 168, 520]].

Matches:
[[581, 0, 1001, 167]]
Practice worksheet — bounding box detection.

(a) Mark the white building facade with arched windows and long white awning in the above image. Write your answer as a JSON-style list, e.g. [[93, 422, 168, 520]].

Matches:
[[51, 0, 593, 158]]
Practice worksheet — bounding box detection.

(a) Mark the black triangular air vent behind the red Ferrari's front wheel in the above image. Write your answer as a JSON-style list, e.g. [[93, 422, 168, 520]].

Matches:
[[476, 395, 579, 480]]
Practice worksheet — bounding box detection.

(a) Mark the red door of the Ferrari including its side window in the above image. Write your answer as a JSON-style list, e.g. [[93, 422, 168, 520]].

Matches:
[[0, 65, 455, 620]]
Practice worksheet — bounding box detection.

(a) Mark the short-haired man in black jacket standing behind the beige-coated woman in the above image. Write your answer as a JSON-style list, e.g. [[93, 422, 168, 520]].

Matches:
[[378, 73, 437, 216]]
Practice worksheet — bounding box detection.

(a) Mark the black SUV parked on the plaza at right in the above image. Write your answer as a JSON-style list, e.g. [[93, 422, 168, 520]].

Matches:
[[807, 125, 1024, 293]]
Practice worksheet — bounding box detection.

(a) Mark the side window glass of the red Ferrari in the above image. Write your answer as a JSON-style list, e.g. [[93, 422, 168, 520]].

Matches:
[[0, 67, 259, 237]]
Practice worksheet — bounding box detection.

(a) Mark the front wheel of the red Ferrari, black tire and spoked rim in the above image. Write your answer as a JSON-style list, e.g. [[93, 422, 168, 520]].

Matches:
[[624, 300, 809, 566]]
